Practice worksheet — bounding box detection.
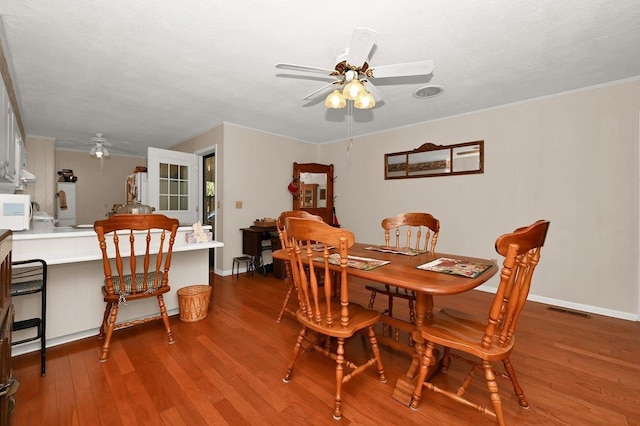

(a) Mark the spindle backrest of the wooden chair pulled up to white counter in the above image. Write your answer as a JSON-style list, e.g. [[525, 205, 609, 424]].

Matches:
[[93, 214, 179, 295]]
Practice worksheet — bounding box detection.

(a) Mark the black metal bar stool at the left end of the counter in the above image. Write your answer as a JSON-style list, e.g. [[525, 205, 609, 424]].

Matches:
[[11, 259, 47, 376]]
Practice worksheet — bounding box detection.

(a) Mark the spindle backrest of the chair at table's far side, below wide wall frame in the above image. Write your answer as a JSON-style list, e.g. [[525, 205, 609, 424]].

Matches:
[[382, 213, 440, 252]]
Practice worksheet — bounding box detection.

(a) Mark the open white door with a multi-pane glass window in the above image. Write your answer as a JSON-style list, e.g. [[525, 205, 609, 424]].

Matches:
[[147, 148, 200, 225]]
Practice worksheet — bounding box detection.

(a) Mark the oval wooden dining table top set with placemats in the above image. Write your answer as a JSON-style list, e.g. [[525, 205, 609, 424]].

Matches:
[[273, 243, 498, 295]]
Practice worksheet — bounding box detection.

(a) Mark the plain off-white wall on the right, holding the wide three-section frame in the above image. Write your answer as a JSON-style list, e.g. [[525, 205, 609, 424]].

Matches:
[[318, 80, 640, 320]]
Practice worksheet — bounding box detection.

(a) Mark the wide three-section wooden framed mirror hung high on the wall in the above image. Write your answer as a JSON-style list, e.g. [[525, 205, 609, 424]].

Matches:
[[384, 141, 484, 179]]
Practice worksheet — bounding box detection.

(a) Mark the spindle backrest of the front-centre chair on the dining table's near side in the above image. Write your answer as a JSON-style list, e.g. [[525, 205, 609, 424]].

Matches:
[[285, 217, 355, 327]]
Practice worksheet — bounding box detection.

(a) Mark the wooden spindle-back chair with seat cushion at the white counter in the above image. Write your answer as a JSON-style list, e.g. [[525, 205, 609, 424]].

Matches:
[[93, 214, 178, 362]]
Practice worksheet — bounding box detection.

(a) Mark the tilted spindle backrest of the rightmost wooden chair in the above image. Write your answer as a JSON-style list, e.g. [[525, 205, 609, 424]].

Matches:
[[481, 220, 549, 349]]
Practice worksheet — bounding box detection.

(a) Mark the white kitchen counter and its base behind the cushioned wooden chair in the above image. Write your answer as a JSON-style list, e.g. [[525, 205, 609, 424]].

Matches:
[[12, 226, 223, 356]]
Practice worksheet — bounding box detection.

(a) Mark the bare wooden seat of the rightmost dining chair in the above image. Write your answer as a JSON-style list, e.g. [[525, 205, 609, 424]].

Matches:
[[421, 309, 516, 361]]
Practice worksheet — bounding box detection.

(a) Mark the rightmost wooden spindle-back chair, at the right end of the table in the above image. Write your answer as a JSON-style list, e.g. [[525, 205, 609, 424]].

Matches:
[[410, 220, 549, 425]]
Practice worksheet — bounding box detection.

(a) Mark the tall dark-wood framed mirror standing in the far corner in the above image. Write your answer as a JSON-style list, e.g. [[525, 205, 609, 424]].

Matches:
[[292, 163, 333, 225]]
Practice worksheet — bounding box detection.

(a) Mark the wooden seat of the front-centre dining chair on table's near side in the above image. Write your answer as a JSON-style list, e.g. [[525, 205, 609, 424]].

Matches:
[[296, 301, 380, 338]]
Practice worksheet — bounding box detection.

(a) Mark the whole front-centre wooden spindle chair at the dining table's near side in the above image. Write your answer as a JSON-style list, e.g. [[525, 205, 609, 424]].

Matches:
[[283, 217, 387, 420]]
